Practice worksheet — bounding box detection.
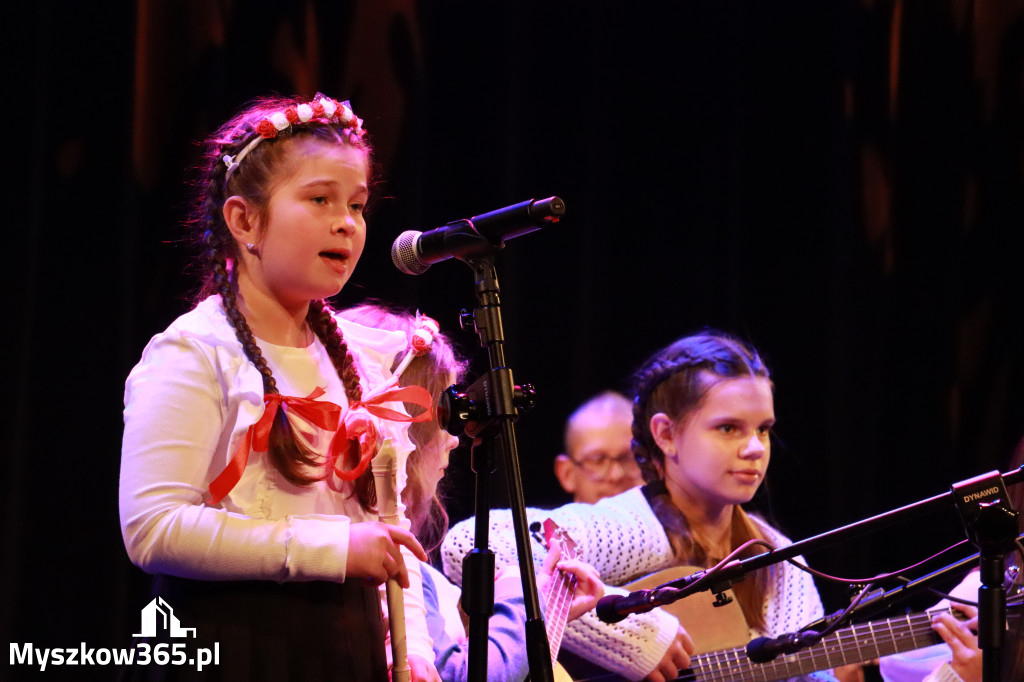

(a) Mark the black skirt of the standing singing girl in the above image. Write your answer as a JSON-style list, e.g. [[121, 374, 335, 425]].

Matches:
[[124, 576, 388, 682]]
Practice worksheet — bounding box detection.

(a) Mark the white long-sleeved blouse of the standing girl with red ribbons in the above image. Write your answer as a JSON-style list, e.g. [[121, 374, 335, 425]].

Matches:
[[119, 296, 433, 660]]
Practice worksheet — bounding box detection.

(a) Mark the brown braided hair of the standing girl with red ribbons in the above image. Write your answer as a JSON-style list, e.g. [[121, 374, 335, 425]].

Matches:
[[188, 97, 376, 509]]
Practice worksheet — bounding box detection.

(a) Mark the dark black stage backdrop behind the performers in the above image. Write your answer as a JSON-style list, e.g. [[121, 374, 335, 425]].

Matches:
[[6, 0, 1024, 679]]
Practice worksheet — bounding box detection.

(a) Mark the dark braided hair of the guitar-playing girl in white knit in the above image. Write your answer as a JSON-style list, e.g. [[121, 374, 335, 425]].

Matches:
[[632, 330, 771, 628]]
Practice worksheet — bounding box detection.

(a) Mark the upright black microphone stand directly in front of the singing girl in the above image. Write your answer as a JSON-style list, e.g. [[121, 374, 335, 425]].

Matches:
[[449, 244, 554, 682]]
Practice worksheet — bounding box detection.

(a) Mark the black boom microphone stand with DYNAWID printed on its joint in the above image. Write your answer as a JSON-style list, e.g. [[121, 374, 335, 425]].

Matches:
[[634, 465, 1024, 682]]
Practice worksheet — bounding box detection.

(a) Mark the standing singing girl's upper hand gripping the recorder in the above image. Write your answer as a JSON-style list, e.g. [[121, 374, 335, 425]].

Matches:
[[345, 521, 427, 589]]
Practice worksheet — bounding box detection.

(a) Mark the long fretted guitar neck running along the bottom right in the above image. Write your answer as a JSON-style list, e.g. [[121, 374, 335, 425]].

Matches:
[[678, 611, 942, 682]]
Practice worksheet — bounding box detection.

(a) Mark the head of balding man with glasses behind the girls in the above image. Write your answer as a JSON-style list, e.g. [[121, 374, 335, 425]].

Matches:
[[555, 391, 643, 504]]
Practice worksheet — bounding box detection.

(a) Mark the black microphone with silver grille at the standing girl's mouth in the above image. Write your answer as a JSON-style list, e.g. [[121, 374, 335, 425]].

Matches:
[[391, 197, 565, 274]]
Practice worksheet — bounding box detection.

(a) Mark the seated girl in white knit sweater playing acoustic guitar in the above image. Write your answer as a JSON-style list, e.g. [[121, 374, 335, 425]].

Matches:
[[441, 332, 831, 682]]
